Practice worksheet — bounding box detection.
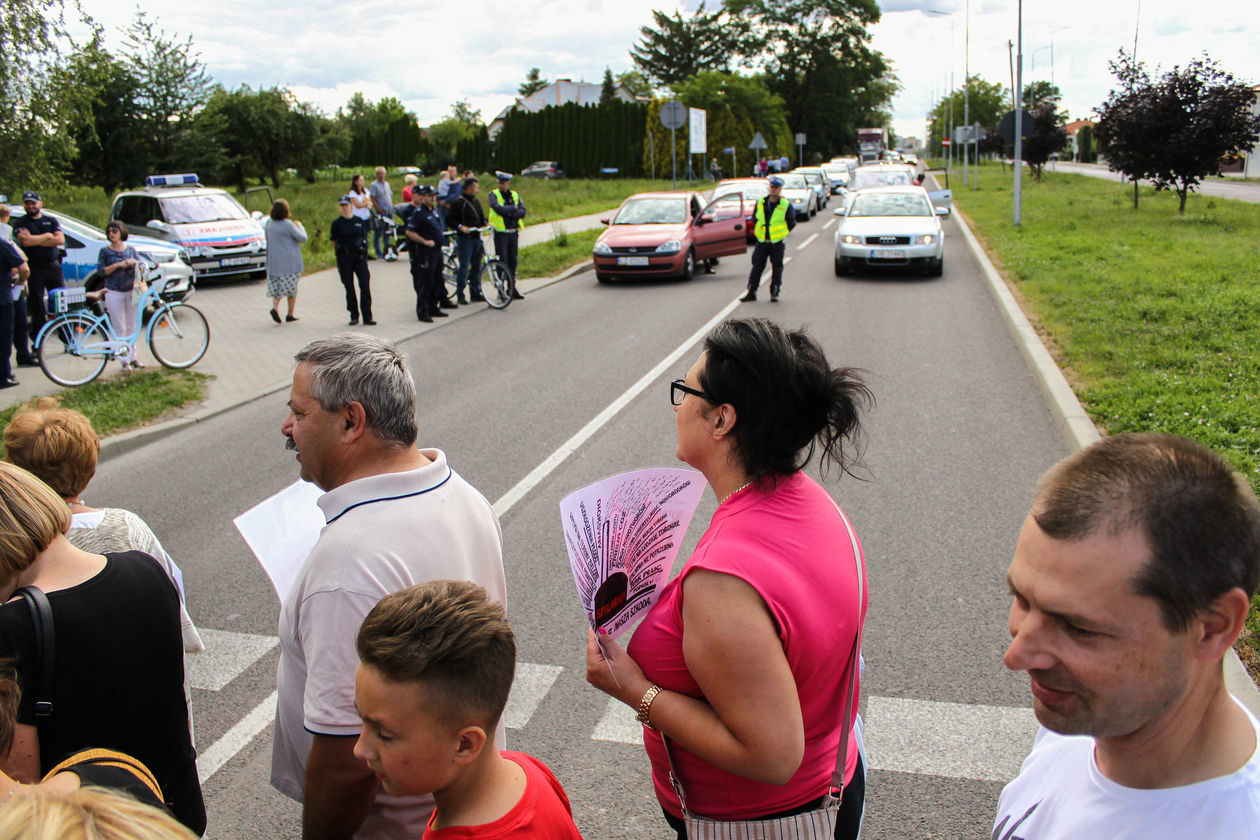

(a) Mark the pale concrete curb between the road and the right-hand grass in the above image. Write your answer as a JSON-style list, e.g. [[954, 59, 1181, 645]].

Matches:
[[954, 208, 1260, 718]]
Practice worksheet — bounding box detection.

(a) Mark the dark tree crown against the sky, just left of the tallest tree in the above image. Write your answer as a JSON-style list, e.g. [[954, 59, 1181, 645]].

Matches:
[[630, 3, 736, 84]]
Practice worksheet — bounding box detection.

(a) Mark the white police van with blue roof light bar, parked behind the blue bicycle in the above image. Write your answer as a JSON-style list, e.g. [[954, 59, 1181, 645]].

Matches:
[[110, 174, 267, 280]]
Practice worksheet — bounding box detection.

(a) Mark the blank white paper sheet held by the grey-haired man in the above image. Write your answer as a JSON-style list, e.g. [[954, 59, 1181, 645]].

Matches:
[[232, 481, 325, 602]]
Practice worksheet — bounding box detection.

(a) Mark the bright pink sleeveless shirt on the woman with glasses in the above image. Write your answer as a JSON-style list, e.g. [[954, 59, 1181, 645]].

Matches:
[[627, 472, 867, 820]]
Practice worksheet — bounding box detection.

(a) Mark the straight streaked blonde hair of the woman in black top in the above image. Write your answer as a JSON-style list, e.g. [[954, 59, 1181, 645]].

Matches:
[[0, 461, 71, 581]]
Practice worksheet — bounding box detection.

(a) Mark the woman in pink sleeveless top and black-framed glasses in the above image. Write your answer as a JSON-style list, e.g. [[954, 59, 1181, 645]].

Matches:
[[587, 320, 872, 839]]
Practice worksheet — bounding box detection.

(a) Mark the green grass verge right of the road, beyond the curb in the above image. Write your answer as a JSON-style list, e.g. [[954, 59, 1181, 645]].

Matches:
[[954, 166, 1260, 678]]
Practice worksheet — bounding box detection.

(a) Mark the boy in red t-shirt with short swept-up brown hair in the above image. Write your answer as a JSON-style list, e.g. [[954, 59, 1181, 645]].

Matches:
[[354, 581, 582, 840]]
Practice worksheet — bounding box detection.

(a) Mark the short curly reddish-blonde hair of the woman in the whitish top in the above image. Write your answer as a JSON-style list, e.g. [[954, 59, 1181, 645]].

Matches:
[[4, 397, 101, 497]]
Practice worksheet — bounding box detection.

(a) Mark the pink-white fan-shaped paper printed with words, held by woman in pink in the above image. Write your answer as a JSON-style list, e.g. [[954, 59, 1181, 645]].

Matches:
[[559, 467, 707, 639]]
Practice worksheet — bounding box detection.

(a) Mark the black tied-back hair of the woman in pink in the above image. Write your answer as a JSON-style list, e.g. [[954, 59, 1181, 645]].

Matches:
[[699, 319, 874, 480]]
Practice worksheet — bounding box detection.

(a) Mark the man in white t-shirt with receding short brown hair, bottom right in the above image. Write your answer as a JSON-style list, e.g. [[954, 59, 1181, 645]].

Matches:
[[993, 433, 1260, 840]]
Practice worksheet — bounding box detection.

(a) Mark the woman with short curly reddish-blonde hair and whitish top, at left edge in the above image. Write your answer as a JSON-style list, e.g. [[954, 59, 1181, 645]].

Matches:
[[4, 397, 205, 654]]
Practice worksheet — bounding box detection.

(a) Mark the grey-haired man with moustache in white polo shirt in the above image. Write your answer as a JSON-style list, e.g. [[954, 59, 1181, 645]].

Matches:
[[271, 332, 507, 840]]
